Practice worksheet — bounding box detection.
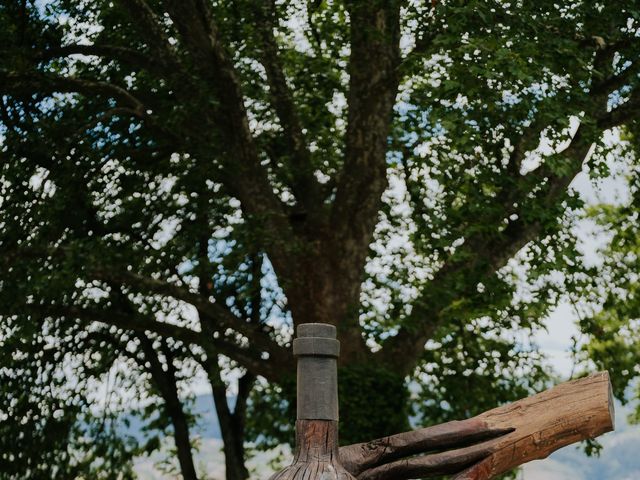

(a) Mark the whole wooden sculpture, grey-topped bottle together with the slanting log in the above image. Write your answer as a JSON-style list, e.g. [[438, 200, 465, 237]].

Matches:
[[271, 323, 614, 480]]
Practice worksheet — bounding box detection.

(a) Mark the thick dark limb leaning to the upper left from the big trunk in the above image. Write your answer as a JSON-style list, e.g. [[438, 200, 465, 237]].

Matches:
[[161, 0, 297, 298]]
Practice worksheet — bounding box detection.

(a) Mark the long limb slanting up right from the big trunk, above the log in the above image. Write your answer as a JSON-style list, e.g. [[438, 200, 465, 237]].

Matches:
[[378, 72, 607, 373]]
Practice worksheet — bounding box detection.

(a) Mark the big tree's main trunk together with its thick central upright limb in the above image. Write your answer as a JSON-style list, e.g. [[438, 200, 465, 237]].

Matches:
[[276, 0, 401, 365]]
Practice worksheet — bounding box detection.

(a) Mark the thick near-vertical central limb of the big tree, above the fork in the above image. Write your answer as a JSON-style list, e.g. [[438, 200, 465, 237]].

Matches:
[[332, 1, 400, 239]]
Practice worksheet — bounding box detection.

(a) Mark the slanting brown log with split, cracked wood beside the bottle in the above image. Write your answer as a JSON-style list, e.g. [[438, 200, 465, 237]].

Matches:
[[340, 372, 614, 480]]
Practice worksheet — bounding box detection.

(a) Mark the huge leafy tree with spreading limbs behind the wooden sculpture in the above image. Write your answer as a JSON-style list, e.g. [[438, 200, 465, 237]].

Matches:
[[0, 0, 640, 479]]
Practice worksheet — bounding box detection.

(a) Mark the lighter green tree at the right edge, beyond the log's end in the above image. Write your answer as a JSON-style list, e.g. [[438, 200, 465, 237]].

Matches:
[[576, 138, 640, 423]]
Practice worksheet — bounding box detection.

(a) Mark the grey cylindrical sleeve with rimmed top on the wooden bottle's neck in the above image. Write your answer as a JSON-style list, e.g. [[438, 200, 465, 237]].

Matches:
[[293, 323, 340, 421]]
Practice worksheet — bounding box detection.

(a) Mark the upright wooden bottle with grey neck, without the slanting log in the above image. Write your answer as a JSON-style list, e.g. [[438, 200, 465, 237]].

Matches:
[[271, 323, 355, 480]]
